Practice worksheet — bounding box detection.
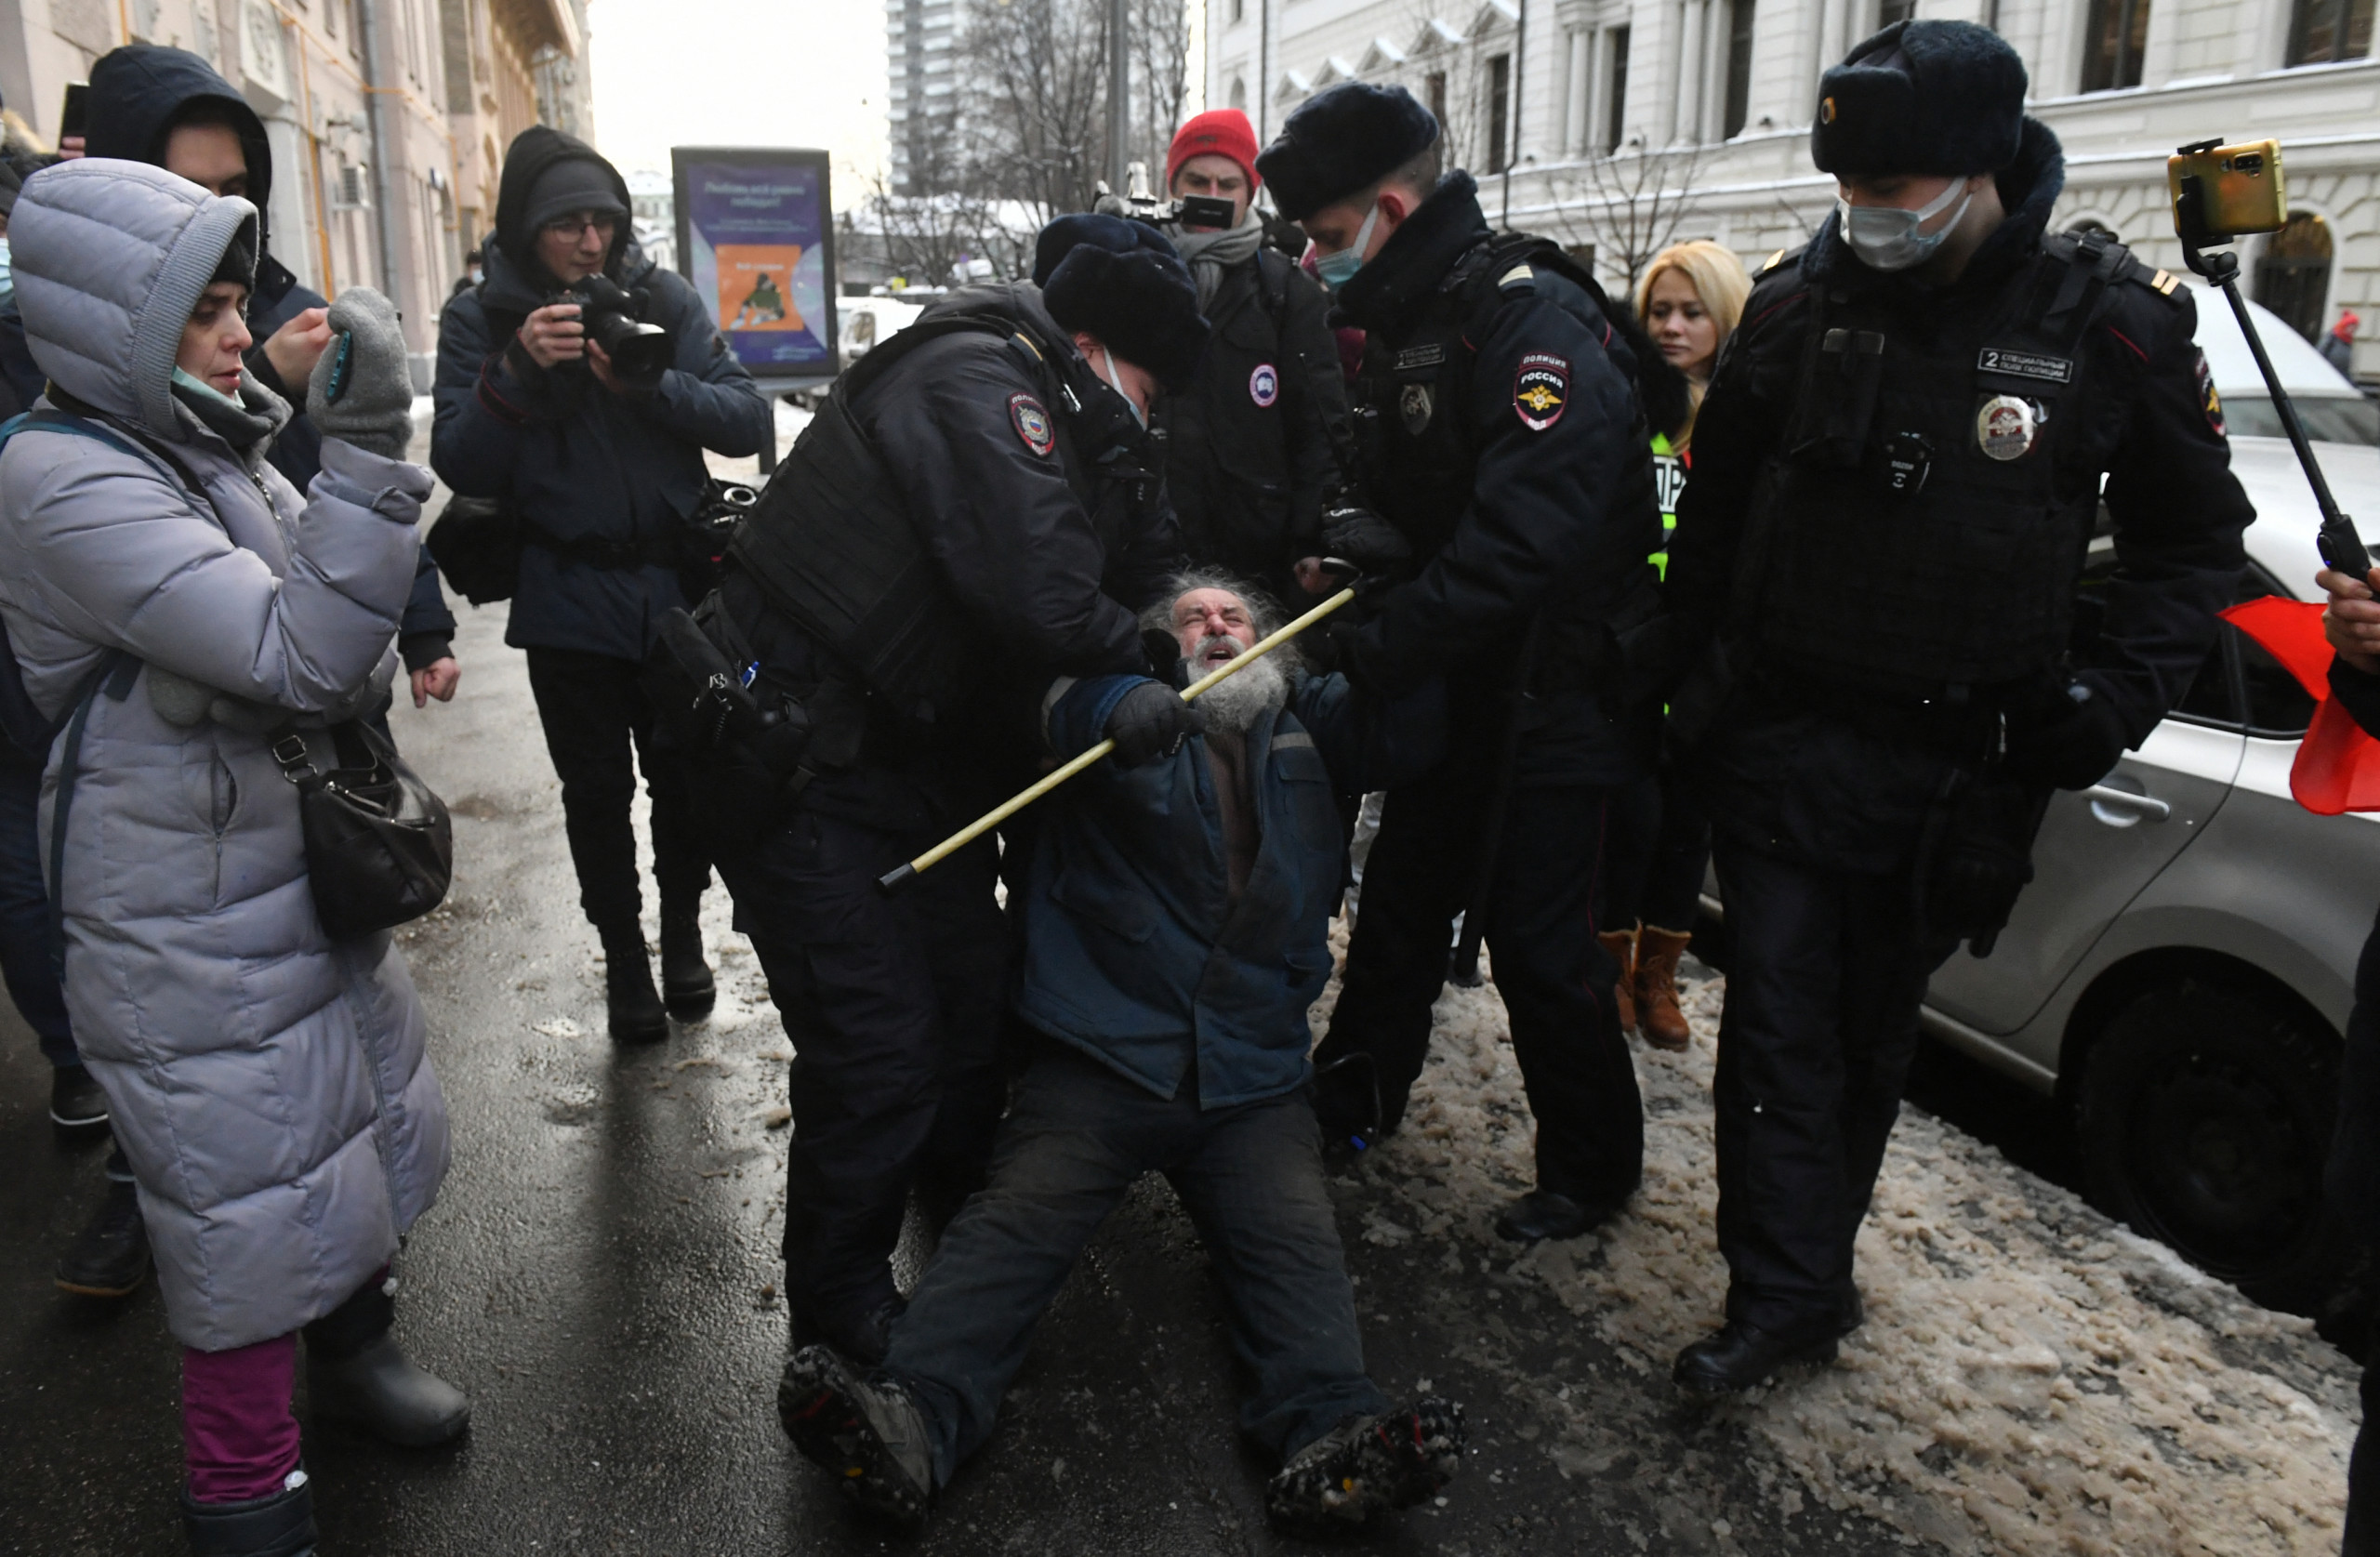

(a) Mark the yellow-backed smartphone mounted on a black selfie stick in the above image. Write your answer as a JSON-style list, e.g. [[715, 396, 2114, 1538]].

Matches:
[[2166, 140, 2373, 581]]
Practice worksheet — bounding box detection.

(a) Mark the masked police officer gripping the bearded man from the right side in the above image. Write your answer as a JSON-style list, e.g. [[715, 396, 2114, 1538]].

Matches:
[[1257, 84, 1683, 1240]]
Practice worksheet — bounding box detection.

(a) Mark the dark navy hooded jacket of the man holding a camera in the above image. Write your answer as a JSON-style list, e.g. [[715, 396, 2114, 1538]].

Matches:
[[430, 126, 774, 659]]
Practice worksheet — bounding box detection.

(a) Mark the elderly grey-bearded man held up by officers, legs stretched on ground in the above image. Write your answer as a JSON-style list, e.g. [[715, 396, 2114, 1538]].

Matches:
[[778, 574, 1463, 1528]]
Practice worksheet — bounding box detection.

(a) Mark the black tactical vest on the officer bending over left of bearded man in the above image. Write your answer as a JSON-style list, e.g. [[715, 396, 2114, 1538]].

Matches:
[[728, 314, 1052, 726]]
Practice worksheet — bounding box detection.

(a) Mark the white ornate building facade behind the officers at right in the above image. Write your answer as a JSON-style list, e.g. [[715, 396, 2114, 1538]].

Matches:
[[1204, 0, 2380, 378]]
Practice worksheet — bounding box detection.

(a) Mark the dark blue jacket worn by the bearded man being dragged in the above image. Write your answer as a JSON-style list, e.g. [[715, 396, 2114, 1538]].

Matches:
[[1016, 676, 1445, 1107]]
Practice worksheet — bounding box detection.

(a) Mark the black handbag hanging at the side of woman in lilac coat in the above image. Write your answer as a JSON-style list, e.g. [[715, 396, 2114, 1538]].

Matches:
[[273, 719, 455, 941]]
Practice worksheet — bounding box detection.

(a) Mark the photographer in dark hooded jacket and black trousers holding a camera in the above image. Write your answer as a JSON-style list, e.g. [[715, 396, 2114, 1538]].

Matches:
[[430, 126, 774, 1040]]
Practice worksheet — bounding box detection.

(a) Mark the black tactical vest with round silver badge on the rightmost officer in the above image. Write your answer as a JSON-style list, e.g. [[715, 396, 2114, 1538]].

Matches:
[[1738, 236, 2147, 695]]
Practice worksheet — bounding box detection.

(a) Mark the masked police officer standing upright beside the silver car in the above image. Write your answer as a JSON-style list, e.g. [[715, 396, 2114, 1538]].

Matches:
[[1666, 21, 2252, 1395]]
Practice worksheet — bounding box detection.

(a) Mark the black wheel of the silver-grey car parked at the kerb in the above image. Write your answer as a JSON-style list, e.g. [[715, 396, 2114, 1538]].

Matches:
[[2075, 983, 2347, 1312]]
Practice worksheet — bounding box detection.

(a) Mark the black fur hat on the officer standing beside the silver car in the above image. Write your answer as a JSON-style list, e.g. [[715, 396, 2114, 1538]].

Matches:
[[1809, 21, 2026, 178]]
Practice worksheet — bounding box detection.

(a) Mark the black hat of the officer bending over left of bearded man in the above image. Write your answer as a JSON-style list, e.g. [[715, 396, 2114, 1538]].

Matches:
[[1033, 215, 1207, 393]]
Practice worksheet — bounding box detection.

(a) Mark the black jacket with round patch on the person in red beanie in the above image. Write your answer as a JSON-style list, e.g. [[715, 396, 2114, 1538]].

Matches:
[[1155, 247, 1347, 600]]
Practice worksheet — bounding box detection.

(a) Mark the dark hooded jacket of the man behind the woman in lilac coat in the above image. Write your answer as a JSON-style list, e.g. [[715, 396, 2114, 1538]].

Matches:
[[75, 43, 455, 669]]
